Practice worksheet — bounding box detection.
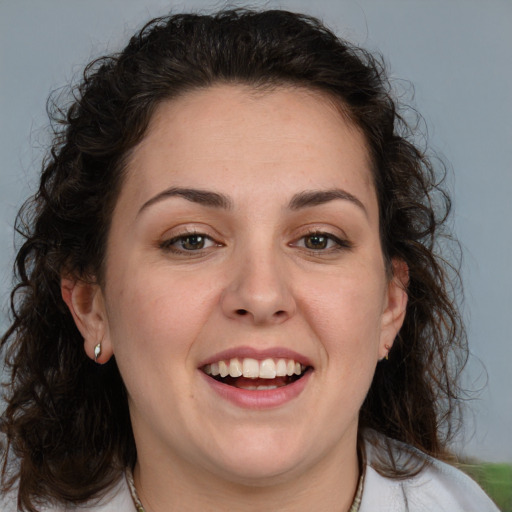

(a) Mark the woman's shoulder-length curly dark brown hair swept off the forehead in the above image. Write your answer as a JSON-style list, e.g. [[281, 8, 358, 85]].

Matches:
[[1, 9, 466, 511]]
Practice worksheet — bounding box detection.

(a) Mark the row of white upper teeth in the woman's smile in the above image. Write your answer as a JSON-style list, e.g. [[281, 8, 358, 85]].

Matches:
[[203, 357, 305, 379]]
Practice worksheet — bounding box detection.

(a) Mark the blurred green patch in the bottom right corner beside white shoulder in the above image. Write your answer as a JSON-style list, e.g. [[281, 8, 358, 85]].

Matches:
[[457, 462, 512, 512]]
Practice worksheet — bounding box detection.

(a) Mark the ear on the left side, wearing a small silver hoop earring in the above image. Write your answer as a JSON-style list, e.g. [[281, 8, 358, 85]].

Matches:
[[60, 277, 113, 364]]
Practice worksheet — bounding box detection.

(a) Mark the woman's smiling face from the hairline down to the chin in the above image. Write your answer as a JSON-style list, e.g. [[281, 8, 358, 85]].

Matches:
[[86, 85, 405, 482]]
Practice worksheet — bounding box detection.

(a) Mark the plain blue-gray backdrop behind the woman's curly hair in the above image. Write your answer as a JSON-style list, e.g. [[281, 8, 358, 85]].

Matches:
[[0, 0, 512, 462]]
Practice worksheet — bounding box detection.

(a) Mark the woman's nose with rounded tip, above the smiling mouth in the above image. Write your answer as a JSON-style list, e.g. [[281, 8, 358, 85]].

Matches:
[[221, 247, 296, 325]]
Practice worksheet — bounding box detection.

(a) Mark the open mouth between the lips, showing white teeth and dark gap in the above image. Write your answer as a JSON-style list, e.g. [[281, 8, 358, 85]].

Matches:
[[201, 358, 311, 391]]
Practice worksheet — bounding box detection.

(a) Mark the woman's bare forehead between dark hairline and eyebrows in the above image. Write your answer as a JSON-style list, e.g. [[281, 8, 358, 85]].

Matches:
[[122, 85, 374, 212]]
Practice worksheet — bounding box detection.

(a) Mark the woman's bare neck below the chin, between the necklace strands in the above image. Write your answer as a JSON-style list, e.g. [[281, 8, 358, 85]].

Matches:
[[134, 436, 360, 512]]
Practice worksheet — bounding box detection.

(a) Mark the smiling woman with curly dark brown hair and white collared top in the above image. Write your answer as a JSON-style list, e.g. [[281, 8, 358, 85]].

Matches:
[[2, 10, 496, 512]]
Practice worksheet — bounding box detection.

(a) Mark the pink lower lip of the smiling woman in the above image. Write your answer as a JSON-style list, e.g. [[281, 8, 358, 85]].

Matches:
[[198, 363, 313, 410]]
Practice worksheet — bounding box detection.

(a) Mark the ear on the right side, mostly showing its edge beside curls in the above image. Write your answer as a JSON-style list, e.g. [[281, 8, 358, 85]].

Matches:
[[379, 258, 409, 359]]
